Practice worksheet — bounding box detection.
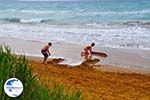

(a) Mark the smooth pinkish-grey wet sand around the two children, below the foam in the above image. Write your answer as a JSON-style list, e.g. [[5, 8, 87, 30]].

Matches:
[[0, 37, 150, 69]]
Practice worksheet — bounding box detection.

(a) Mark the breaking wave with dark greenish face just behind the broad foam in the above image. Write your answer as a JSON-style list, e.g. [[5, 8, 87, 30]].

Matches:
[[0, 18, 150, 28]]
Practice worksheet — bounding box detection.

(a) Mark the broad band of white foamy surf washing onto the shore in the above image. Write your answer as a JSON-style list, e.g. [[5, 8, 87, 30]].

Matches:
[[0, 23, 150, 49]]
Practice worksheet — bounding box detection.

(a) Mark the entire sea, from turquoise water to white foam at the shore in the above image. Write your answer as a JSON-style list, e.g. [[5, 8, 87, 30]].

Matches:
[[0, 0, 150, 50]]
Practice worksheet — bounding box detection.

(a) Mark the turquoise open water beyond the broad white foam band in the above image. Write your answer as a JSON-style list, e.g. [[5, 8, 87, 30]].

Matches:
[[0, 0, 150, 24]]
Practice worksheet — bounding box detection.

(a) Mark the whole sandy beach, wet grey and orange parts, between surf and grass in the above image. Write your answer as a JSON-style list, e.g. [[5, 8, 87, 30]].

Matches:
[[0, 37, 150, 100]]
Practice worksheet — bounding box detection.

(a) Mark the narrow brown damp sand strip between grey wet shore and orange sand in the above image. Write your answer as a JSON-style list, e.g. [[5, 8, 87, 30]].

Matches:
[[26, 56, 150, 75]]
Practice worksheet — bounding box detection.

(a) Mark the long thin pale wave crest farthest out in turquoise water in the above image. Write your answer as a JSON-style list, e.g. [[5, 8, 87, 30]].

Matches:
[[0, 9, 150, 16]]
